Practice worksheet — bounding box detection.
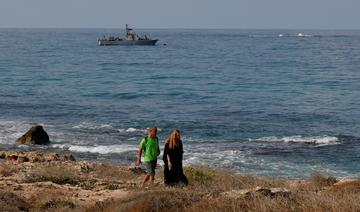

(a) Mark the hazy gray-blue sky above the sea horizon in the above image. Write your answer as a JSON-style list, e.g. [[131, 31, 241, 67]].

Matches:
[[0, 0, 360, 29]]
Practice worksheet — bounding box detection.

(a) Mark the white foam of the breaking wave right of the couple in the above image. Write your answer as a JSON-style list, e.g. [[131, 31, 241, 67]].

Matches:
[[255, 135, 339, 145]]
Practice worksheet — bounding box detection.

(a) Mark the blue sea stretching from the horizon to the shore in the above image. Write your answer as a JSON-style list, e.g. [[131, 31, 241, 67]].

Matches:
[[0, 29, 360, 178]]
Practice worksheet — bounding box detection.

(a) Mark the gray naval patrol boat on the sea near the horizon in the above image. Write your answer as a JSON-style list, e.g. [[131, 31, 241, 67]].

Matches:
[[98, 24, 158, 46]]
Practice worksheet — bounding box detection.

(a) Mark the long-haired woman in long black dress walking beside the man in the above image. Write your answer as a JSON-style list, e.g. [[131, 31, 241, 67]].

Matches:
[[163, 129, 188, 185]]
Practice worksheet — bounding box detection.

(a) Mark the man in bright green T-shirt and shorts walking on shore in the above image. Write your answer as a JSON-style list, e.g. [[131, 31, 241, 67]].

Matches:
[[136, 126, 160, 187]]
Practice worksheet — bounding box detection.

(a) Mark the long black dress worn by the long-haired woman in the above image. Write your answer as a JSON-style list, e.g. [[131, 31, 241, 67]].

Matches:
[[163, 141, 188, 185]]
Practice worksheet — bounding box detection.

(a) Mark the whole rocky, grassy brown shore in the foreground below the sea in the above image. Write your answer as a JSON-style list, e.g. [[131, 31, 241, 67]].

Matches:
[[0, 151, 360, 211]]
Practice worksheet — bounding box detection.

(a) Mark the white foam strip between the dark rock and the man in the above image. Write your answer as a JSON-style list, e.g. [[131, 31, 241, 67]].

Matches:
[[52, 144, 137, 154]]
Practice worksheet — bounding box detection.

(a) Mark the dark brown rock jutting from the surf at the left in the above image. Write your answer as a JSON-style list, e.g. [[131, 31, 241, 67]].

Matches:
[[16, 125, 50, 145]]
